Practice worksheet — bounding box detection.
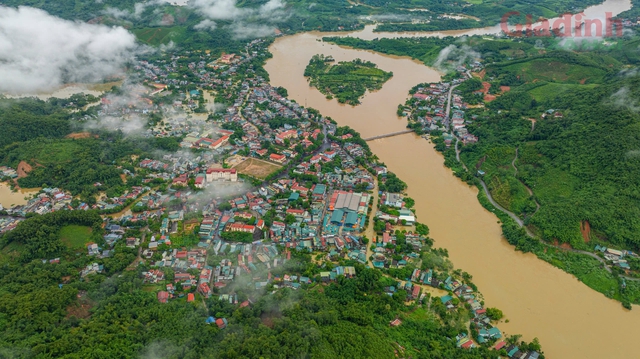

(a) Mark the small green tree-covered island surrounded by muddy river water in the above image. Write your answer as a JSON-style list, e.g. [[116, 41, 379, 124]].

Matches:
[[304, 55, 393, 106]]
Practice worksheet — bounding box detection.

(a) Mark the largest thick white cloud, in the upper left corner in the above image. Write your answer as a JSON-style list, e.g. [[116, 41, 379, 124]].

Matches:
[[0, 7, 137, 94]]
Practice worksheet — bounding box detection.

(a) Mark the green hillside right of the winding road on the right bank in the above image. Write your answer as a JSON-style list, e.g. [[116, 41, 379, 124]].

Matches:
[[461, 46, 640, 249]]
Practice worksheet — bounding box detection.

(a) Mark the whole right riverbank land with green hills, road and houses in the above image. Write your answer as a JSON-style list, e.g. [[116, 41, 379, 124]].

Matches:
[[325, 28, 640, 308]]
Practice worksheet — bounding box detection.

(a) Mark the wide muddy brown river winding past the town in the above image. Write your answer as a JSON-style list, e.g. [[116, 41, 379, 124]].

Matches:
[[266, 0, 640, 358]]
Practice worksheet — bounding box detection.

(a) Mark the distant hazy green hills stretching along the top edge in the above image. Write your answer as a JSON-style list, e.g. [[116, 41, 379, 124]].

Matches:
[[3, 0, 601, 52]]
